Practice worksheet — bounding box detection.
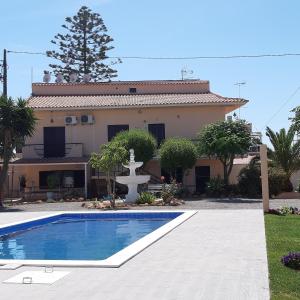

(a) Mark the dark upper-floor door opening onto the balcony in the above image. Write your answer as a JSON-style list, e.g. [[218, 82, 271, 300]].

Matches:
[[44, 127, 66, 157]]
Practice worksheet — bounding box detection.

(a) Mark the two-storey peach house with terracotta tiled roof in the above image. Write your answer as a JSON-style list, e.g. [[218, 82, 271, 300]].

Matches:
[[8, 80, 247, 196]]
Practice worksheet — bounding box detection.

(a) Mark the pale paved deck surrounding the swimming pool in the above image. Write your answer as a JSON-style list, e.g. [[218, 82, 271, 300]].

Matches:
[[0, 209, 269, 300]]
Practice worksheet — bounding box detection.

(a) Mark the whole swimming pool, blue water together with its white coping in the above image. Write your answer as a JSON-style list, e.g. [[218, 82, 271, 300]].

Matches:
[[0, 211, 195, 267]]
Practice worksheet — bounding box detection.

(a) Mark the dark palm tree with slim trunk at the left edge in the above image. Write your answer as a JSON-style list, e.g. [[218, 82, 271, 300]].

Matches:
[[0, 96, 37, 207]]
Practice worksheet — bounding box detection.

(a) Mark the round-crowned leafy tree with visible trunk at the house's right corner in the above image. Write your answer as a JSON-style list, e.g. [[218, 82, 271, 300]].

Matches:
[[198, 120, 251, 184]]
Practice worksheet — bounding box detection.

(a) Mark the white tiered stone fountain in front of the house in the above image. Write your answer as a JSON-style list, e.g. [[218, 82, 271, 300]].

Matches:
[[116, 149, 150, 202]]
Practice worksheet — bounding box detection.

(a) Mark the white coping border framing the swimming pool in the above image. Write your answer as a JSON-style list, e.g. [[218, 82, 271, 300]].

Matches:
[[0, 209, 198, 268]]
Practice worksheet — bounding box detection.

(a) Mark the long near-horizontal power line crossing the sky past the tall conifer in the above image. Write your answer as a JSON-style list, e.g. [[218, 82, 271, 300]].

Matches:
[[7, 50, 300, 60]]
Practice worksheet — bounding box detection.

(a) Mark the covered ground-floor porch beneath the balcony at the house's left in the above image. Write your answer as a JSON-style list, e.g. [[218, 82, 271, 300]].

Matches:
[[5, 157, 90, 200]]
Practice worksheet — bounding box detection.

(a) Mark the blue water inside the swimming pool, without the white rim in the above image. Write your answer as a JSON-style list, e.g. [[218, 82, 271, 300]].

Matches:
[[0, 212, 181, 260]]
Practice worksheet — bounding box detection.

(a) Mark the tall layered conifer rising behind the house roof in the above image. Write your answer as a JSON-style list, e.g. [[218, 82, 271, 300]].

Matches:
[[47, 6, 121, 81]]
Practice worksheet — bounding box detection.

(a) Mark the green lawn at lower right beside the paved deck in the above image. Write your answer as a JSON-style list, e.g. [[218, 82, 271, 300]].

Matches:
[[265, 214, 300, 300]]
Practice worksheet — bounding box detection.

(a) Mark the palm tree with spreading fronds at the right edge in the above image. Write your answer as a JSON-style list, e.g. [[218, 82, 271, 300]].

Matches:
[[266, 126, 300, 191]]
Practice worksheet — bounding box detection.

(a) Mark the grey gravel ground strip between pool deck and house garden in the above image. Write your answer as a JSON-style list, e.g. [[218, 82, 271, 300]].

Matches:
[[2, 199, 300, 212]]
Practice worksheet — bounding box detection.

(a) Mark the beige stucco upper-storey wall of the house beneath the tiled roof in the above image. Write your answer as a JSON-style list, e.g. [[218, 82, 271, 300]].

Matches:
[[26, 106, 226, 155]]
